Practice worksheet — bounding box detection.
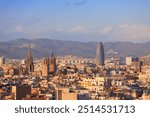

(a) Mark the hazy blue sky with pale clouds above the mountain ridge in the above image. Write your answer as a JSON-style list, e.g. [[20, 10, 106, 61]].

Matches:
[[0, 0, 150, 42]]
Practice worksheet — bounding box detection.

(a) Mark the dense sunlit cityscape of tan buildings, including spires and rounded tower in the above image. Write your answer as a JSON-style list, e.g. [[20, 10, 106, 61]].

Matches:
[[0, 42, 150, 100]]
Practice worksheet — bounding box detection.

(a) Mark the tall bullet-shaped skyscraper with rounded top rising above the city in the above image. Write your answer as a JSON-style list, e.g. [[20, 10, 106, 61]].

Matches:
[[95, 42, 105, 66]]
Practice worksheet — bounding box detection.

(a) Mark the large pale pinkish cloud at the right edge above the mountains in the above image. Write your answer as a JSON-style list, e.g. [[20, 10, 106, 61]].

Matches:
[[113, 23, 150, 41]]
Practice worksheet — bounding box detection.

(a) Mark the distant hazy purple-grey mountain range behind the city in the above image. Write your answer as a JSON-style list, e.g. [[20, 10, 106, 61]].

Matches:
[[0, 39, 150, 58]]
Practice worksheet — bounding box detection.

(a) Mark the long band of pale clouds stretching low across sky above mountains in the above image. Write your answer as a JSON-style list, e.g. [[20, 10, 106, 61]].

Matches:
[[1, 23, 150, 42]]
